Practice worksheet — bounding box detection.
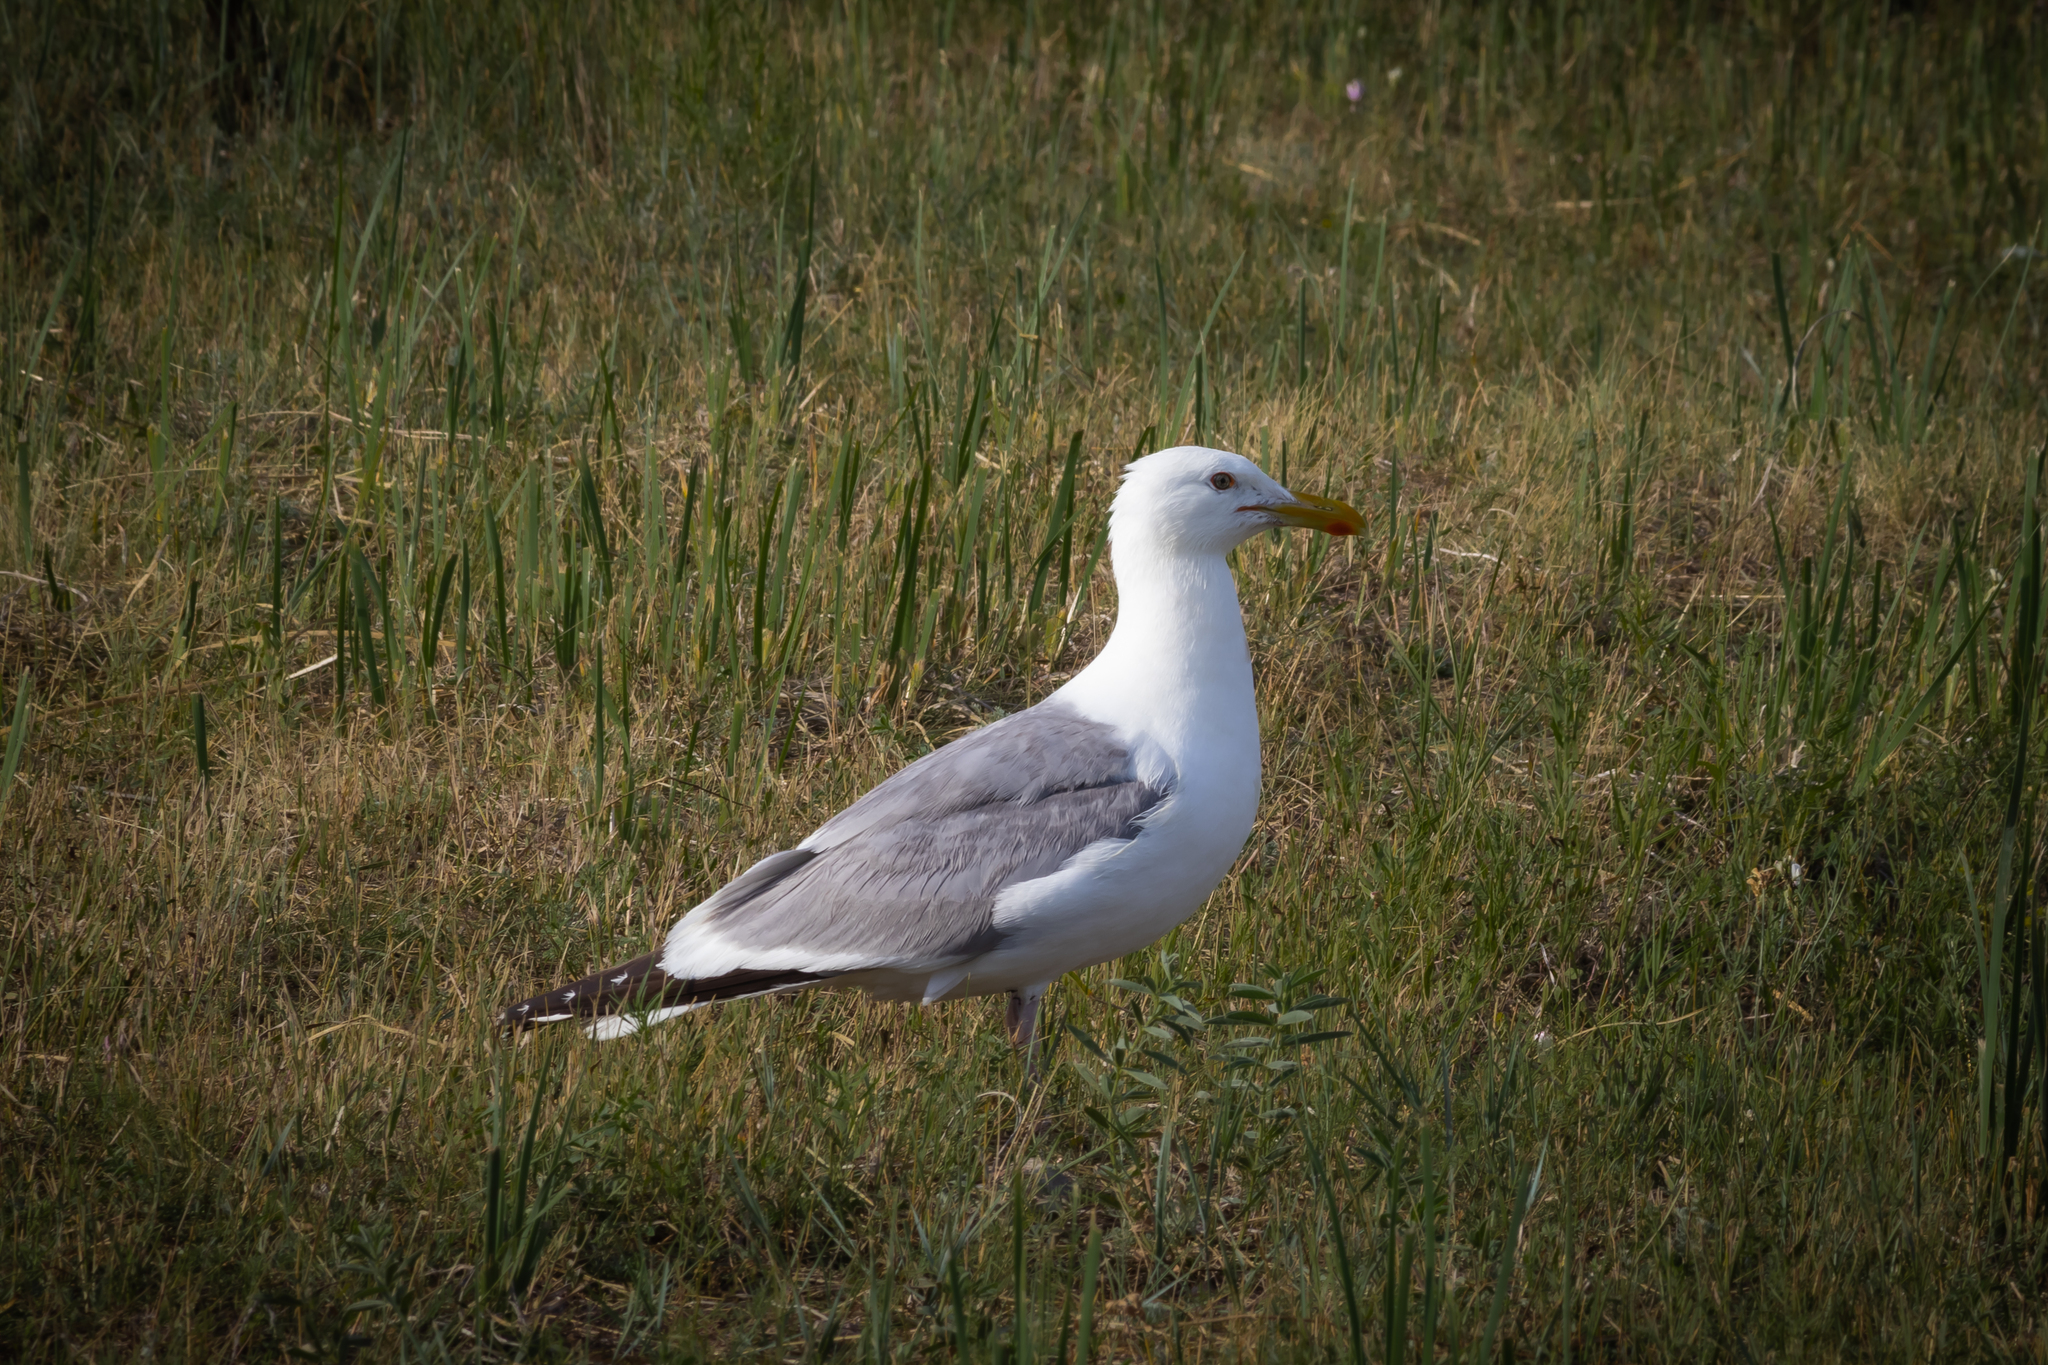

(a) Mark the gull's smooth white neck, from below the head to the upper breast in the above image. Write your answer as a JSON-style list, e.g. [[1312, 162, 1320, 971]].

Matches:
[[1055, 536, 1260, 772]]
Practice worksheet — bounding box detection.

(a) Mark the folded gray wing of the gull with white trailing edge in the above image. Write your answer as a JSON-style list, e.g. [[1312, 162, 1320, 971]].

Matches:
[[670, 706, 1167, 968]]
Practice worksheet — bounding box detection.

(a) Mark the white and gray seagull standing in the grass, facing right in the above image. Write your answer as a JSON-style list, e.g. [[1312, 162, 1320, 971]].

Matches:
[[498, 446, 1364, 1070]]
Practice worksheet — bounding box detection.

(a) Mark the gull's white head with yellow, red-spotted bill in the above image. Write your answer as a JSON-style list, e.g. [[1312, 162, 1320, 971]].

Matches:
[[1110, 446, 1366, 555]]
